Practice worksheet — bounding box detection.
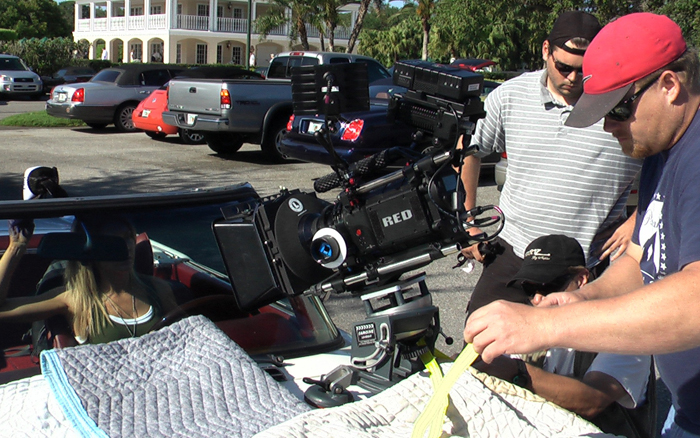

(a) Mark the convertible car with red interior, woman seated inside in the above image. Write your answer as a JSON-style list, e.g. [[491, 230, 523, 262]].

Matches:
[[0, 184, 345, 383]]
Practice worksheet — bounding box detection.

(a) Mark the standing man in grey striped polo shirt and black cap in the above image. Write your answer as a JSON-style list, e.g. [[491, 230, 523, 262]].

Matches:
[[461, 11, 641, 314]]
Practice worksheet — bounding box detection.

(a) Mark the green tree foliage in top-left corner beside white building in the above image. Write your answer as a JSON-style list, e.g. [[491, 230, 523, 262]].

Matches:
[[0, 0, 73, 38]]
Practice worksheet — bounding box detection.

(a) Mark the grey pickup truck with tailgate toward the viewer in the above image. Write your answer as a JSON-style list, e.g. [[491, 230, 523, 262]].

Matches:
[[163, 52, 391, 161]]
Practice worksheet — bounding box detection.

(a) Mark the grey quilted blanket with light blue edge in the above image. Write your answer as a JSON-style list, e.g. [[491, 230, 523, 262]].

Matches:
[[36, 316, 310, 438]]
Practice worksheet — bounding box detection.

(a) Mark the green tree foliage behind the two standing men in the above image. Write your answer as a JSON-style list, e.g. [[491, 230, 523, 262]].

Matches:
[[360, 0, 700, 70]]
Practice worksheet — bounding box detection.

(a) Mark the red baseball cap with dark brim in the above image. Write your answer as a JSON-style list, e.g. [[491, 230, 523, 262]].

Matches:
[[565, 12, 686, 128]]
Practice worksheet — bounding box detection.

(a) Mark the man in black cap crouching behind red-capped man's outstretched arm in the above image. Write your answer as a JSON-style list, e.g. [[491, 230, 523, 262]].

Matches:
[[474, 235, 656, 437]]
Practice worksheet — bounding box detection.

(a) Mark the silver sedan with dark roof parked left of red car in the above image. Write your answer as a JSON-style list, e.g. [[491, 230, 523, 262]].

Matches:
[[46, 64, 184, 132]]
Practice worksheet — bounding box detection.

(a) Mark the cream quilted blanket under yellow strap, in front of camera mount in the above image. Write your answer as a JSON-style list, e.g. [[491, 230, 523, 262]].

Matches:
[[255, 364, 610, 438]]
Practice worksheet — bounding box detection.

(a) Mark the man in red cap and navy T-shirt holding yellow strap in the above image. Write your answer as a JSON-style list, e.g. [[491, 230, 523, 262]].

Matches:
[[464, 13, 700, 437]]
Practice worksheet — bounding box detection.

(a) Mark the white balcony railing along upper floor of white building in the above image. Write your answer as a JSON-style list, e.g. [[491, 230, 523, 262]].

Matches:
[[76, 14, 350, 40]]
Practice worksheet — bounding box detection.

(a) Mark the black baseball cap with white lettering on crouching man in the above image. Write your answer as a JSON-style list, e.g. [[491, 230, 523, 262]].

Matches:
[[508, 234, 586, 285]]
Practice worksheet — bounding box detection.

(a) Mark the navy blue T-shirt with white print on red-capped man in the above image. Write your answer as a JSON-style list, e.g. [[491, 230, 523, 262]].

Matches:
[[633, 113, 700, 435]]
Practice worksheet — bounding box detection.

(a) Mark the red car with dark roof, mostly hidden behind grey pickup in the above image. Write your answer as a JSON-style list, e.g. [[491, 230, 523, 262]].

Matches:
[[132, 66, 263, 144]]
